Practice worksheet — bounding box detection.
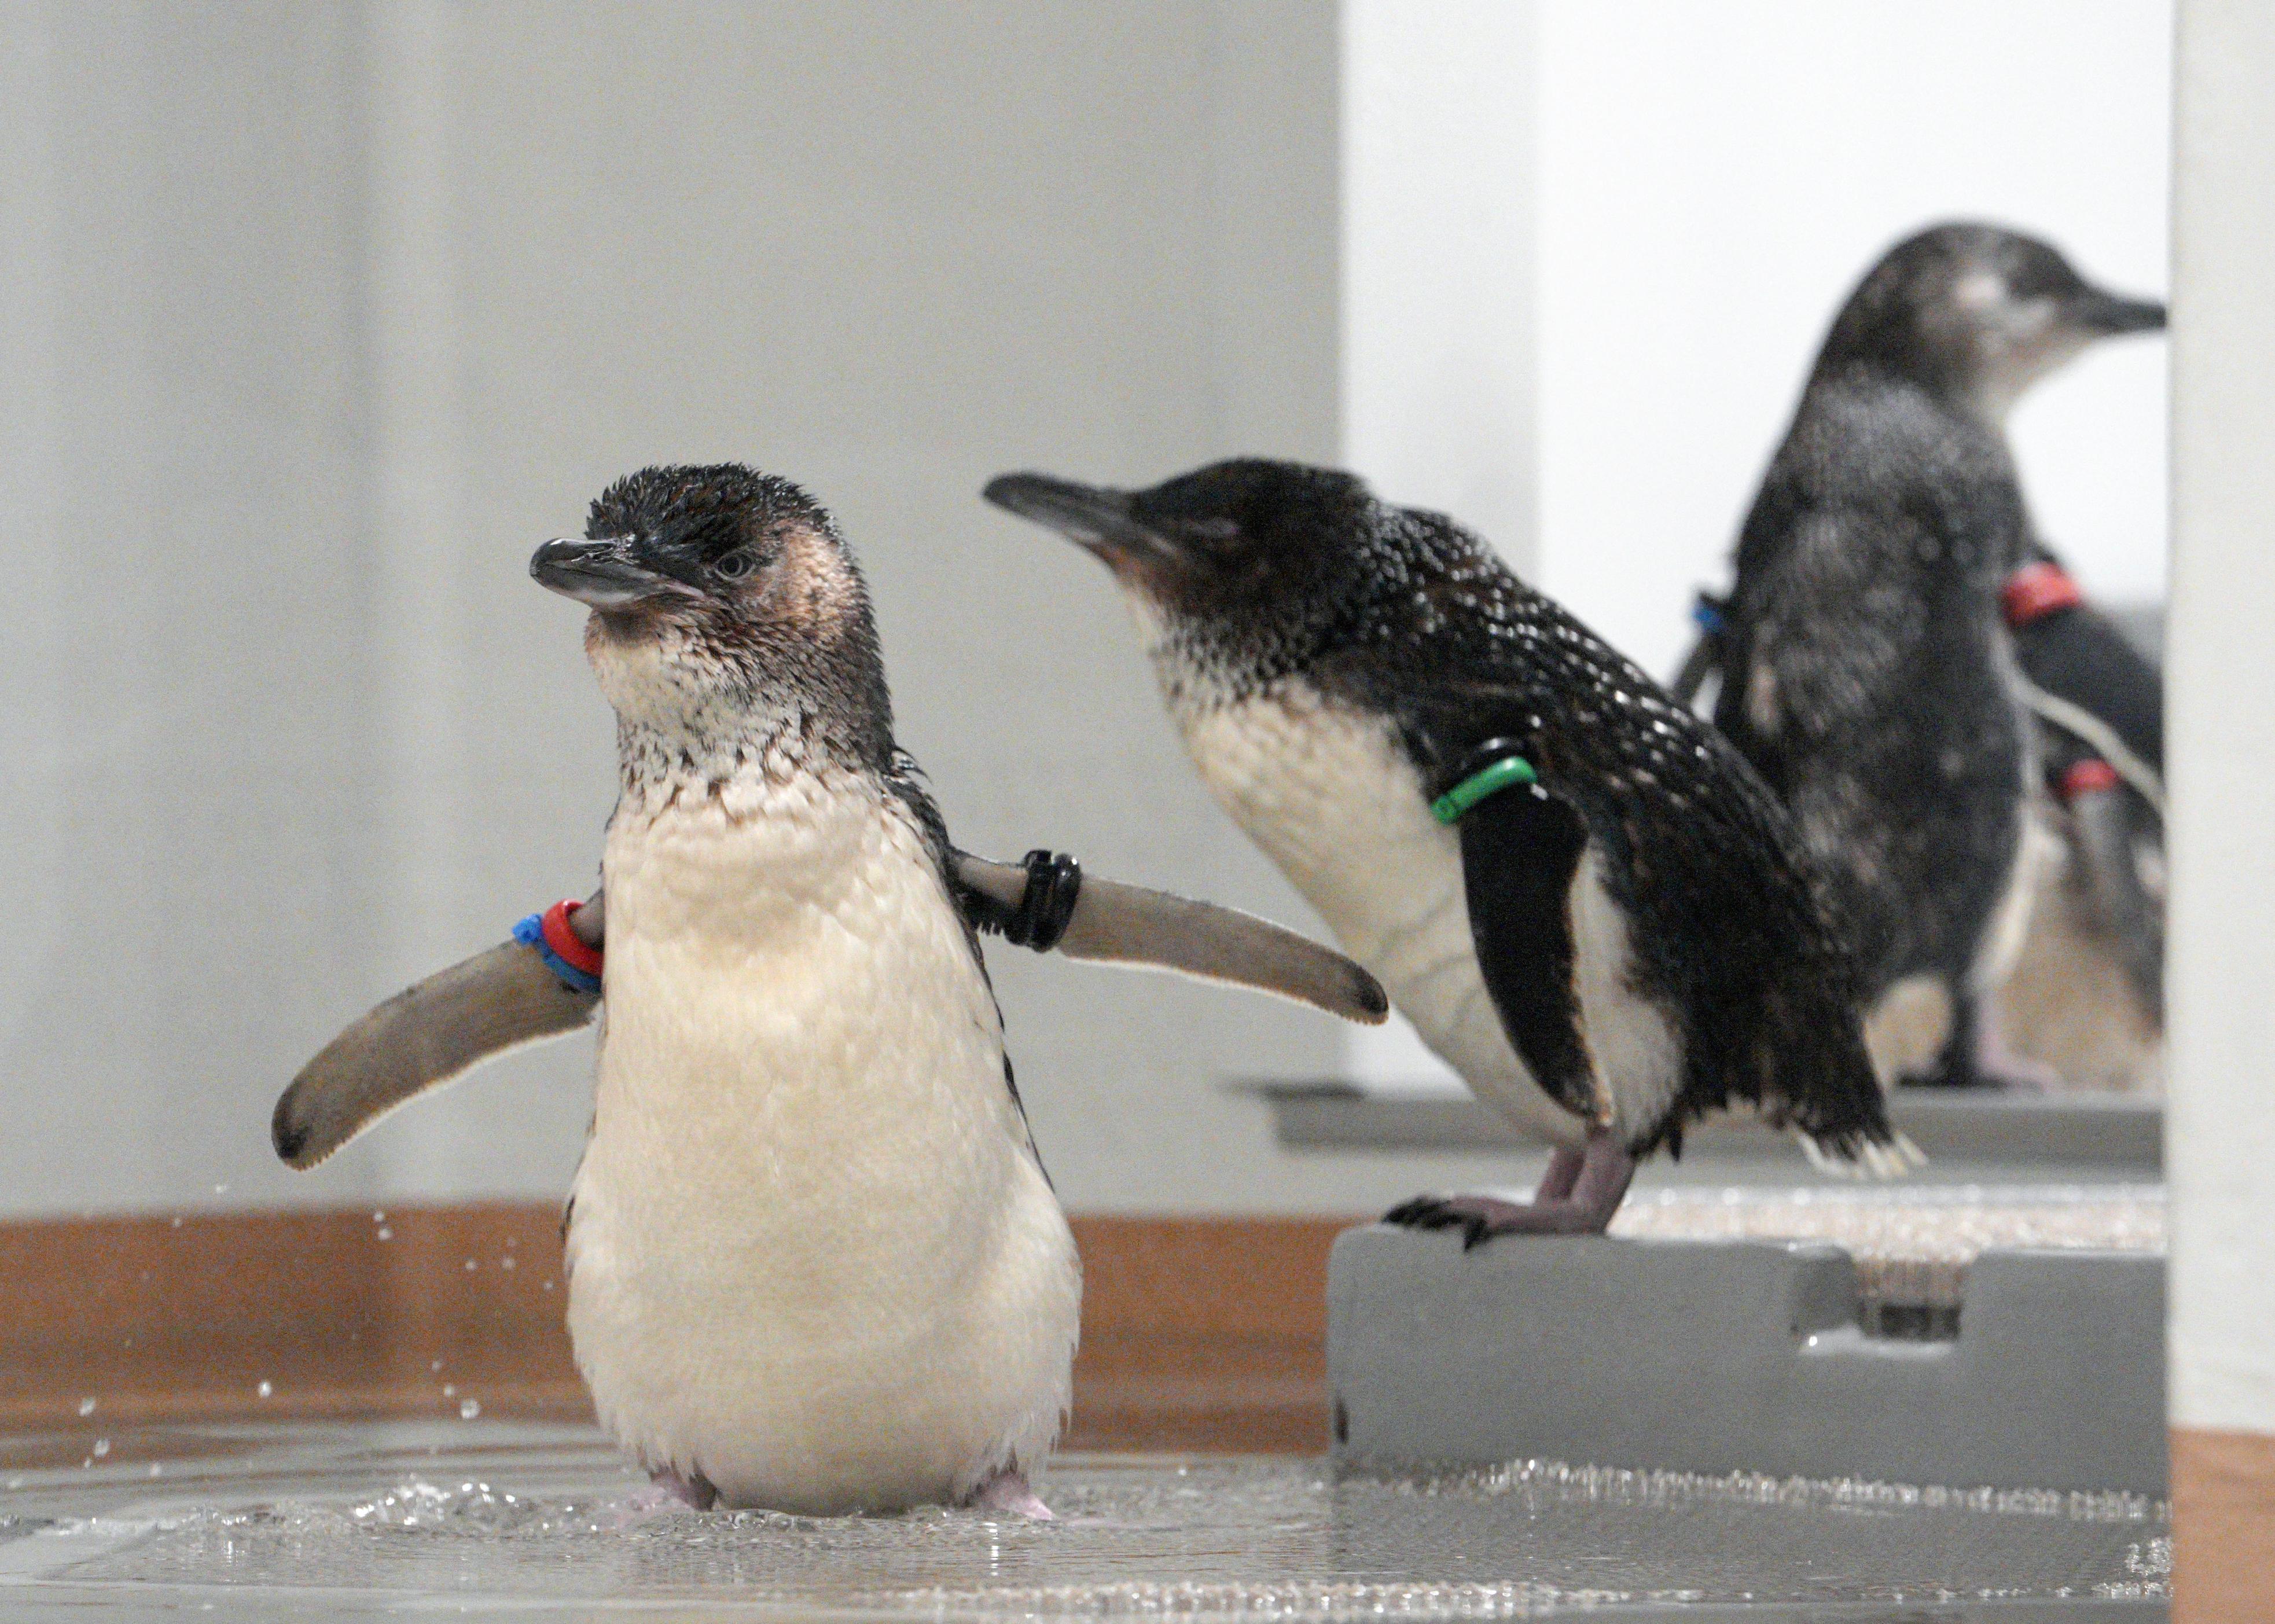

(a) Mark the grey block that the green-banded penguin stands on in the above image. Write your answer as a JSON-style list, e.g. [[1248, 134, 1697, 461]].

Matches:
[[1326, 1223, 2168, 1499]]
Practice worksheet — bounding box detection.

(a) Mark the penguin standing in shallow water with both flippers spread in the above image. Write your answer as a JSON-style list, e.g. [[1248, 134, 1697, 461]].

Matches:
[[275, 466, 1381, 1515]]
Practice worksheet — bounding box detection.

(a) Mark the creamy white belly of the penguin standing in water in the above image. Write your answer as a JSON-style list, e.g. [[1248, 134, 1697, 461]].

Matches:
[[569, 785, 1080, 1512]]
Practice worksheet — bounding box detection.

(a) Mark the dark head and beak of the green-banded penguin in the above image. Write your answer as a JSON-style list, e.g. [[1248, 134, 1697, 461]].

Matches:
[[983, 457, 1388, 668]]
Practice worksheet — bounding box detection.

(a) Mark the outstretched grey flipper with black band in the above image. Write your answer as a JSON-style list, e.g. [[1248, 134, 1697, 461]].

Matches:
[[953, 851, 1390, 1026]]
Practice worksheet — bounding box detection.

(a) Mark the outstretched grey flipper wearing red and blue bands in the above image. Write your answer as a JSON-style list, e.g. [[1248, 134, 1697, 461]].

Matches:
[[269, 923, 601, 1169]]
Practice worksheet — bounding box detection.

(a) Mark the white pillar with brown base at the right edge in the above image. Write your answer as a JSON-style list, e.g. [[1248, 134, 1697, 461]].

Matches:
[[2166, 0, 2275, 1592]]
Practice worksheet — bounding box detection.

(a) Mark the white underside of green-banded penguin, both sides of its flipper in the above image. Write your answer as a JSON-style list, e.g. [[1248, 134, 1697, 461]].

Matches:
[[1171, 682, 1681, 1144]]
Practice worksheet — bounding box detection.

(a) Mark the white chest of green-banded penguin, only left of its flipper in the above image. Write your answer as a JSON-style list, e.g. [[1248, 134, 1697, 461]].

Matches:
[[1178, 685, 1586, 1144]]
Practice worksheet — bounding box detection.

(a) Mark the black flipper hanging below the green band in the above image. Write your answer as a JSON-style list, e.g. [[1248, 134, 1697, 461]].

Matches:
[[1456, 764, 1608, 1121]]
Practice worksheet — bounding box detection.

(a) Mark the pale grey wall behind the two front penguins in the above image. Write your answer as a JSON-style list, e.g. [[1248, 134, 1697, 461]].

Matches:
[[0, 0, 1547, 1213]]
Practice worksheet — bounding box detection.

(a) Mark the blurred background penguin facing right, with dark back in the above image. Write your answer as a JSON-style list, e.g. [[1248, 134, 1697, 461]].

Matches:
[[1713, 225, 2163, 1085]]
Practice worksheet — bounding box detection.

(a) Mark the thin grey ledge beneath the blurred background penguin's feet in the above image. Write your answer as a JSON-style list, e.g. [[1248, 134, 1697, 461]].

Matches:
[[1255, 1081, 2163, 1178]]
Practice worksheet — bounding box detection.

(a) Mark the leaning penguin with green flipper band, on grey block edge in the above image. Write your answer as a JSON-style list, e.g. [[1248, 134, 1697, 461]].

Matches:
[[985, 460, 1899, 1247]]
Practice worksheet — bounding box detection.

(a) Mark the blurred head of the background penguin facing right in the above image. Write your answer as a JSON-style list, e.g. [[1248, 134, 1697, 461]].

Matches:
[[1818, 225, 2163, 418]]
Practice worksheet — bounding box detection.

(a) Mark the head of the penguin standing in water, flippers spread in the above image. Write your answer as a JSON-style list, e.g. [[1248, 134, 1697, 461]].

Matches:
[[530, 464, 892, 751]]
